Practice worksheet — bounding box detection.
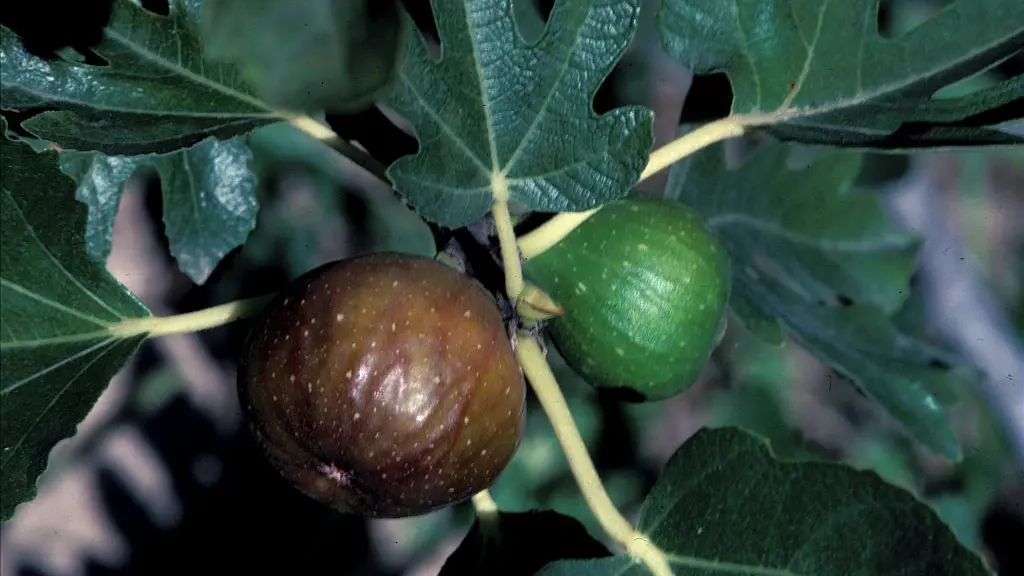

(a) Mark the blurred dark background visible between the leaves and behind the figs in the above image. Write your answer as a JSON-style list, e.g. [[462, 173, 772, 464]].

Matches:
[[4, 0, 1024, 574]]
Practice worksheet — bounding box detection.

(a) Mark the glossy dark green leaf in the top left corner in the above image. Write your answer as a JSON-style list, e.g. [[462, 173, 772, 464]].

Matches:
[[0, 0, 282, 155]]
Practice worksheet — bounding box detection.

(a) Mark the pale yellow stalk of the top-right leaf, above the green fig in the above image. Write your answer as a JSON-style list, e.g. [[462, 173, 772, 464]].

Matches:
[[518, 116, 752, 260]]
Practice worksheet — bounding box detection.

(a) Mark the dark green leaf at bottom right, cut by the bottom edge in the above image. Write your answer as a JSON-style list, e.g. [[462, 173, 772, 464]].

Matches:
[[541, 428, 990, 576]]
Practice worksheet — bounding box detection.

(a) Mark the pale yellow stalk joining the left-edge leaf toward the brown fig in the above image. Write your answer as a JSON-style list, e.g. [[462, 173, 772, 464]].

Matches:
[[108, 295, 272, 338]]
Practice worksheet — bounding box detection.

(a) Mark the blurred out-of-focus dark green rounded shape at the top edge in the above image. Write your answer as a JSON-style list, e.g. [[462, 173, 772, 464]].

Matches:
[[202, 0, 403, 112]]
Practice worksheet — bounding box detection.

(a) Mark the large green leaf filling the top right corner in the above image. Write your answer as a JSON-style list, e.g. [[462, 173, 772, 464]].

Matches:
[[657, 0, 1024, 150]]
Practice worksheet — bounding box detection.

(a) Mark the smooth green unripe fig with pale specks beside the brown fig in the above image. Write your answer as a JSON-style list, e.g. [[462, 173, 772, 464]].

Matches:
[[524, 197, 731, 401]]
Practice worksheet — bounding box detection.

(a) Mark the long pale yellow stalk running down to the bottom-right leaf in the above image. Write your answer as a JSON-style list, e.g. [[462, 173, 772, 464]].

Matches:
[[516, 332, 672, 576]]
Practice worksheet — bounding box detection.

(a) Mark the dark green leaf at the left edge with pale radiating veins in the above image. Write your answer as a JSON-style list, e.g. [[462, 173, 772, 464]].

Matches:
[[0, 118, 148, 520]]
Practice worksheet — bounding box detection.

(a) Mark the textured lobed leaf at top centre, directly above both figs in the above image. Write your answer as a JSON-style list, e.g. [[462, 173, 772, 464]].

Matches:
[[385, 0, 653, 227]]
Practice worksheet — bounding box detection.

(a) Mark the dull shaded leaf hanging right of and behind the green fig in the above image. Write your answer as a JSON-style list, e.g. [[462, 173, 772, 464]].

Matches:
[[667, 143, 959, 460]]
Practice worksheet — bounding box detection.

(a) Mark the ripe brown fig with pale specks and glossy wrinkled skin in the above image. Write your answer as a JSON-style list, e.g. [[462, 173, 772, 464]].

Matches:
[[239, 253, 525, 518]]
